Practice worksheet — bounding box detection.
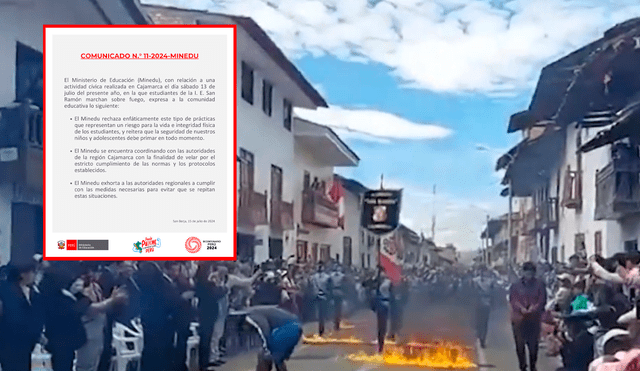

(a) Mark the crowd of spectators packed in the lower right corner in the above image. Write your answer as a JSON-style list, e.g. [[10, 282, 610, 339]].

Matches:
[[504, 251, 640, 371]]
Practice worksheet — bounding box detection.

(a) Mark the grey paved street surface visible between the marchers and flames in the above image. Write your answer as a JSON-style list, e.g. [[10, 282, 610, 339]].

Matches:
[[214, 299, 559, 371]]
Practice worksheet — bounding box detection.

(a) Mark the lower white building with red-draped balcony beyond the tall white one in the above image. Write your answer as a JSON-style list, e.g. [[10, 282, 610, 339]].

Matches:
[[285, 117, 360, 265]]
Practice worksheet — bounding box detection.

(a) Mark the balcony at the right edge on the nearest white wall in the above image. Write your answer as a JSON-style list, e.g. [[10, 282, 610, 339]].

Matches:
[[595, 158, 640, 220]]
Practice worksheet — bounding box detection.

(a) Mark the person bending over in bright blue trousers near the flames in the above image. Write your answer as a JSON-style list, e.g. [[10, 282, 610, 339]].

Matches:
[[246, 306, 302, 371]]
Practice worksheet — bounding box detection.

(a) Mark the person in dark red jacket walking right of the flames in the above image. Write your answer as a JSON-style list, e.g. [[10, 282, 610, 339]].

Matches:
[[509, 262, 547, 371]]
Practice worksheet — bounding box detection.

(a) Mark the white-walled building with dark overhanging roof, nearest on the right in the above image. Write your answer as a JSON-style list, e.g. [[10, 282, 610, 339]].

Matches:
[[498, 19, 640, 262]]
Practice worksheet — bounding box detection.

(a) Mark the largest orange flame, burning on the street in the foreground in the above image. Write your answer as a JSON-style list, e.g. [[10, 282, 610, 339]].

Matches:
[[347, 344, 477, 370]]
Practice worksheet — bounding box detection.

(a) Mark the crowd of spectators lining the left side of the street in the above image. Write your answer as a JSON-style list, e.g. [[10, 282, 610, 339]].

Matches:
[[0, 257, 384, 371]]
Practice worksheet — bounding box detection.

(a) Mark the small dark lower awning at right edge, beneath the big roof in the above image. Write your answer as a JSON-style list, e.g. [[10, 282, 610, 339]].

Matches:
[[580, 99, 640, 152]]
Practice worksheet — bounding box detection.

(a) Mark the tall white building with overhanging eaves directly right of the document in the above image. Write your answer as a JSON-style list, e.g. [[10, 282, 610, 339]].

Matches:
[[144, 6, 327, 262]]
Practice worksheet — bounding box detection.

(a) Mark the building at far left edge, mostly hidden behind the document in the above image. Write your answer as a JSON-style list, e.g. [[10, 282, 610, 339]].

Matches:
[[0, 0, 148, 264]]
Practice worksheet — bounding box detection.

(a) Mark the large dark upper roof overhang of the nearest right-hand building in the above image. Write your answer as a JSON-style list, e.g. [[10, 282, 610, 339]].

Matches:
[[524, 18, 640, 130]]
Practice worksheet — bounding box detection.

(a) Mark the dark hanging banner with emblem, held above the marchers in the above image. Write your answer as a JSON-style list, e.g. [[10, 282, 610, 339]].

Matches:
[[362, 190, 402, 235]]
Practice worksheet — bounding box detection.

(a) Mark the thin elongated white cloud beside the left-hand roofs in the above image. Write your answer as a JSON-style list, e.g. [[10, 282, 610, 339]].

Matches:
[[296, 107, 453, 143]]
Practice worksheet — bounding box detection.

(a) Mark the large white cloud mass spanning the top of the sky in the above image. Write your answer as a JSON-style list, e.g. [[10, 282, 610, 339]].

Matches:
[[142, 0, 640, 96]]
